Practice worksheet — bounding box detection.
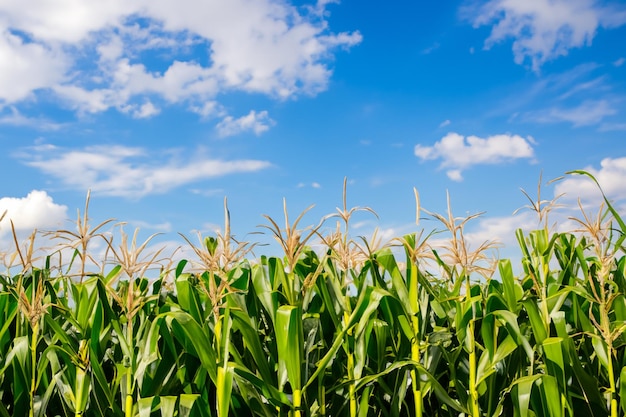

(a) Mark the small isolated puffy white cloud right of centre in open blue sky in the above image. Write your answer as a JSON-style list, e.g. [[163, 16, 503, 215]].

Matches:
[[414, 133, 534, 181]]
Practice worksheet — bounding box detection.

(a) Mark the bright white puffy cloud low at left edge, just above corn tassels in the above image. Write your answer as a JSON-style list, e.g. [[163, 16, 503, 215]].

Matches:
[[0, 190, 67, 237]]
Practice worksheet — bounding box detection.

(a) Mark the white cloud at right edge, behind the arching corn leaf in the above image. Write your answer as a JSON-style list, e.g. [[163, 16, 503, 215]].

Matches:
[[554, 157, 626, 206]]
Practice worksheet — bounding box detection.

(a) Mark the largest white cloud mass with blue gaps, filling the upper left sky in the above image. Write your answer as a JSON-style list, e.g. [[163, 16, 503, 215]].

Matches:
[[0, 0, 361, 132]]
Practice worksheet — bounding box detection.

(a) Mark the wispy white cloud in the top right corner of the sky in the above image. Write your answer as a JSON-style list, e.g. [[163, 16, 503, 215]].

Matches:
[[464, 0, 626, 70]]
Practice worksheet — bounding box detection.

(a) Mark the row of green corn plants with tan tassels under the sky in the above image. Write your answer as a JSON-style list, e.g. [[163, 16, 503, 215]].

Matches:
[[0, 172, 626, 417]]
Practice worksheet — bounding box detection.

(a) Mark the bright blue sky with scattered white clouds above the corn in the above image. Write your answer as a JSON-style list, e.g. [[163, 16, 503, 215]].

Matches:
[[0, 0, 626, 264]]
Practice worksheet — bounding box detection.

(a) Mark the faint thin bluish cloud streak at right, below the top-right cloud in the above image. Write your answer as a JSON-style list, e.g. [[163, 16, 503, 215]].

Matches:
[[528, 100, 617, 127]]
